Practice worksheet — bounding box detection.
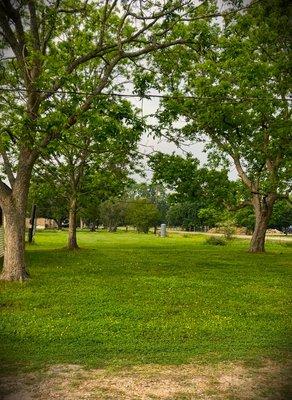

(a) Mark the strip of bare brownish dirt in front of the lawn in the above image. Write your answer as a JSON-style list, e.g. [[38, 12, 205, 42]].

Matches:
[[0, 360, 292, 400]]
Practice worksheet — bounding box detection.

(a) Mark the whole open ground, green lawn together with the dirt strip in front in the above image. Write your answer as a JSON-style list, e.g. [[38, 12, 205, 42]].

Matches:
[[0, 232, 292, 400]]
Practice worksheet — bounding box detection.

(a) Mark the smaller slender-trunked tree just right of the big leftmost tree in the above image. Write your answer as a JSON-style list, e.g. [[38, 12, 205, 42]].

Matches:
[[35, 95, 142, 250]]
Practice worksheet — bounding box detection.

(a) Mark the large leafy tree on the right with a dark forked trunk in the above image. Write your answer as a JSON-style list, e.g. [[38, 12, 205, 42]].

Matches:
[[157, 0, 292, 252]]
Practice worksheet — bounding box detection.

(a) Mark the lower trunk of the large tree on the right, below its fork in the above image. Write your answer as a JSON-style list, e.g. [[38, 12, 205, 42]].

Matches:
[[249, 197, 274, 253]]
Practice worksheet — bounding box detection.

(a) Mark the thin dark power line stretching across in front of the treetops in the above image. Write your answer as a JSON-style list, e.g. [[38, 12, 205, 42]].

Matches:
[[0, 87, 292, 103]]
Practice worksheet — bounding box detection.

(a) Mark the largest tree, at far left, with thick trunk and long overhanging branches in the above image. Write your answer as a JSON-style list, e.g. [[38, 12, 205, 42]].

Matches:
[[0, 0, 212, 280]]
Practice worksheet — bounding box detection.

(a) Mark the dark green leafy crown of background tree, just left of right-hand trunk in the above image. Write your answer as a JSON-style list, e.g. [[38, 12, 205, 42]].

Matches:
[[149, 153, 240, 230]]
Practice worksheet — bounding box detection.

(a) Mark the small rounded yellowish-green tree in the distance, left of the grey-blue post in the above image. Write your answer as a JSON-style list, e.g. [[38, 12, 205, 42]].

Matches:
[[126, 198, 159, 233]]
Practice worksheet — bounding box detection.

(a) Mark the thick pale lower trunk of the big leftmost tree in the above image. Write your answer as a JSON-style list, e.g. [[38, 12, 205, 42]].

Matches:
[[0, 199, 28, 281]]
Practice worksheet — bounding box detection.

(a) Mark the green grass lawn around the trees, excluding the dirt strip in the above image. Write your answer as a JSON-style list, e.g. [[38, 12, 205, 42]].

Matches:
[[0, 232, 292, 371]]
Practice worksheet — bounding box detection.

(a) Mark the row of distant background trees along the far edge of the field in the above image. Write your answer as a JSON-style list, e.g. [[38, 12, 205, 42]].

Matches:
[[27, 159, 292, 239]]
